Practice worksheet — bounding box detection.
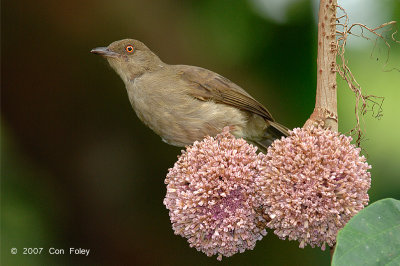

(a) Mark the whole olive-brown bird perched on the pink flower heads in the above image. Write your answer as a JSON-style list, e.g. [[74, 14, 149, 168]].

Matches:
[[91, 39, 288, 150]]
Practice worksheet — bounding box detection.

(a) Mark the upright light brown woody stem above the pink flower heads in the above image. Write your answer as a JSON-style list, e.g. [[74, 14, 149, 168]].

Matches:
[[304, 0, 338, 131]]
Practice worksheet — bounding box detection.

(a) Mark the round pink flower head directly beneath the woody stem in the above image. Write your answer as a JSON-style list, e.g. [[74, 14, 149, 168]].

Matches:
[[257, 128, 371, 249]]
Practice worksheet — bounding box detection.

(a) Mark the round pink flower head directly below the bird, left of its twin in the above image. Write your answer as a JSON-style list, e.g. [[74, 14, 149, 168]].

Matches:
[[164, 129, 266, 259]]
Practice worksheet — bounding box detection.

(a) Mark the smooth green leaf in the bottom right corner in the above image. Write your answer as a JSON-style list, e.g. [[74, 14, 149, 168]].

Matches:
[[332, 199, 400, 266]]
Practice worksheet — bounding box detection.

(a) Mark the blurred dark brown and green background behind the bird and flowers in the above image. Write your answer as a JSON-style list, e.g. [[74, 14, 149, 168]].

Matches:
[[0, 0, 400, 265]]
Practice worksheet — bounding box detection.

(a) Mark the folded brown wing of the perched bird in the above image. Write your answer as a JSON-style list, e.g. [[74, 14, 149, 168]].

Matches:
[[177, 65, 274, 121]]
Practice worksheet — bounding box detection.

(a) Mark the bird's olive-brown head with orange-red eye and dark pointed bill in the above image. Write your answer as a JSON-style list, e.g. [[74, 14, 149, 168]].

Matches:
[[90, 39, 164, 82]]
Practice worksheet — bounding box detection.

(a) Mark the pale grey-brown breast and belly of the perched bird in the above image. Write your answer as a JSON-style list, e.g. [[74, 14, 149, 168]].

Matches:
[[127, 77, 255, 146]]
